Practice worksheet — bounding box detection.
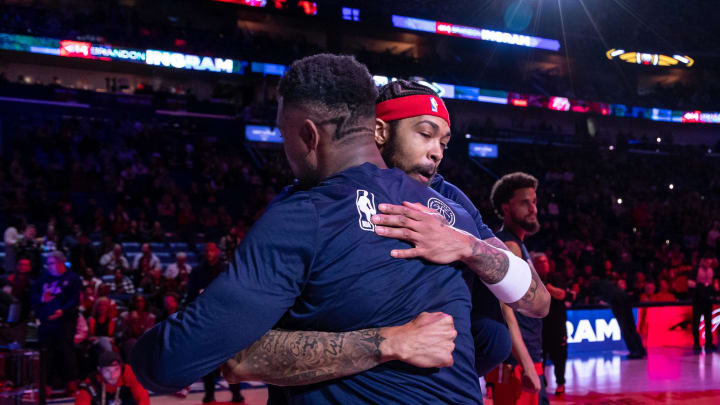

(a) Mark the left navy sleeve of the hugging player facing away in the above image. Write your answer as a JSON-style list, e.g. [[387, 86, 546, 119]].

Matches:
[[130, 196, 318, 393]]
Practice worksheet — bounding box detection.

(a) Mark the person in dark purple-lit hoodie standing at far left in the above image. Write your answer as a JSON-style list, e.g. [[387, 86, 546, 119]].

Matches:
[[32, 251, 82, 387]]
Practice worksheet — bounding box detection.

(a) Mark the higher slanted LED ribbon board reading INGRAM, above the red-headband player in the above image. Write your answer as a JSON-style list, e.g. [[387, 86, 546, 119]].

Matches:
[[392, 15, 560, 51]]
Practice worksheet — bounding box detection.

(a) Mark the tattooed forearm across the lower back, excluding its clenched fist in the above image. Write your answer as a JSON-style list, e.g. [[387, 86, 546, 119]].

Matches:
[[233, 328, 385, 386]]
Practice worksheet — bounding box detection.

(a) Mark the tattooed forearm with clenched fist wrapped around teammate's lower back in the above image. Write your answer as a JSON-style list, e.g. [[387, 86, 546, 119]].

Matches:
[[223, 312, 457, 386]]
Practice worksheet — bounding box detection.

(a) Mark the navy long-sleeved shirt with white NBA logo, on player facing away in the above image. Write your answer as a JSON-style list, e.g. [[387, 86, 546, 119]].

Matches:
[[131, 163, 481, 404]]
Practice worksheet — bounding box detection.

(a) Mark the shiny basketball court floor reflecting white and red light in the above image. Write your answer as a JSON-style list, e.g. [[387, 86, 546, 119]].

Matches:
[[126, 348, 720, 405]]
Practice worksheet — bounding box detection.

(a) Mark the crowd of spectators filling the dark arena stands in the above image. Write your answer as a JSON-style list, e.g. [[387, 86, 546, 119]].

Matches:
[[0, 96, 720, 392]]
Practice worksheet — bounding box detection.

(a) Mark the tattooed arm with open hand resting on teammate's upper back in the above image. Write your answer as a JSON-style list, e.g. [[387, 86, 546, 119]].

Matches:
[[372, 202, 550, 318]]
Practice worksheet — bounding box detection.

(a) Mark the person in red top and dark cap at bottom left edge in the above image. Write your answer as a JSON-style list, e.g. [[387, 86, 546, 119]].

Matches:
[[75, 352, 150, 405]]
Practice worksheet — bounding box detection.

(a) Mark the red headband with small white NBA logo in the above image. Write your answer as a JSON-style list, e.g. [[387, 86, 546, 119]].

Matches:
[[375, 95, 450, 126]]
